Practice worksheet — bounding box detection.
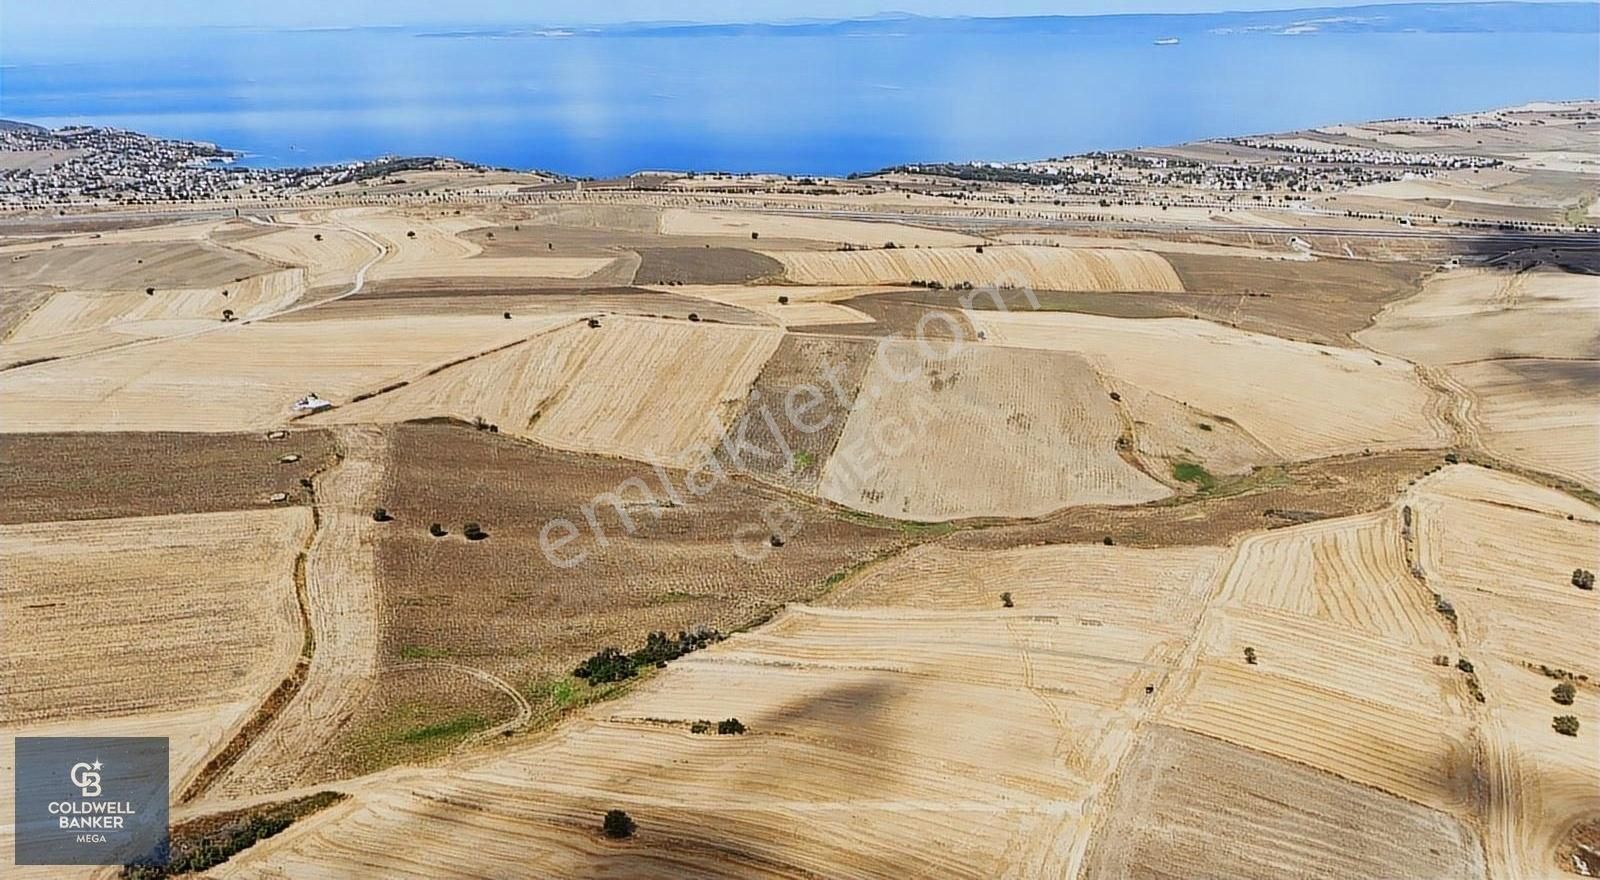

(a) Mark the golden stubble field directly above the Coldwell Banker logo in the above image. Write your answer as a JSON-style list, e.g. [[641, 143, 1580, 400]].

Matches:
[[0, 509, 310, 725]]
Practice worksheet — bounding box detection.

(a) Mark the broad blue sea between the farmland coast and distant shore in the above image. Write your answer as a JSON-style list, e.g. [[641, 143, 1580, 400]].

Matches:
[[0, 8, 1600, 176]]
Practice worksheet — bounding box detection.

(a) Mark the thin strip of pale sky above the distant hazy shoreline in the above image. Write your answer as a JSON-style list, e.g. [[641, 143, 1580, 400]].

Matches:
[[0, 0, 1548, 30]]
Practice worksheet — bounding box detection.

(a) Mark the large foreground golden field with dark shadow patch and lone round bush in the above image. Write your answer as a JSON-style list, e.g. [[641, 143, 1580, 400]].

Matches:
[[212, 547, 1216, 878]]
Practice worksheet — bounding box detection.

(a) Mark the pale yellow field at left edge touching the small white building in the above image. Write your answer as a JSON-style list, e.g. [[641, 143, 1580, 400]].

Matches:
[[0, 315, 566, 432]]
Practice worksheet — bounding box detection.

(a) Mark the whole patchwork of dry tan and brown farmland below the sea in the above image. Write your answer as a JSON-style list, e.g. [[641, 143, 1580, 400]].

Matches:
[[0, 101, 1600, 880]]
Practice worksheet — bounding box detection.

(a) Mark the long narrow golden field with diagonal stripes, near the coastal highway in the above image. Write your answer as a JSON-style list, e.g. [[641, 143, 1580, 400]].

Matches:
[[763, 245, 1184, 293]]
